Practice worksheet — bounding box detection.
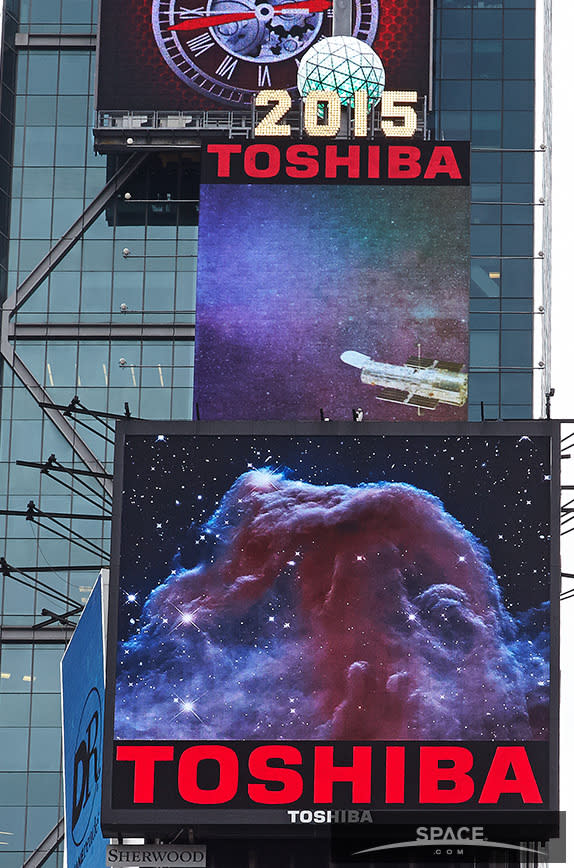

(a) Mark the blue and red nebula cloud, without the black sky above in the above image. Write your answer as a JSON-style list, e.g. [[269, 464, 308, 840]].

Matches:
[[115, 464, 549, 740]]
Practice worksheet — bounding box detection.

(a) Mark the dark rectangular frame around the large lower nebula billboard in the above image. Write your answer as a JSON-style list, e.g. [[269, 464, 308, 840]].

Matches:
[[101, 420, 561, 837]]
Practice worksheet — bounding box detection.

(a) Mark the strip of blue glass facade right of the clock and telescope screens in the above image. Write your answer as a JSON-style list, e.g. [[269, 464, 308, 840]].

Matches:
[[434, 0, 540, 420]]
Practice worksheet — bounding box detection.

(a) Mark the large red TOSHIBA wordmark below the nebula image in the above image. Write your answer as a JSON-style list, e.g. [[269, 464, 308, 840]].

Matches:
[[110, 742, 548, 809]]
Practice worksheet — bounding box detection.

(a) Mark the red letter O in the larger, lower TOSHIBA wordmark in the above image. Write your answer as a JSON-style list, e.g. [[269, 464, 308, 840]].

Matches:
[[177, 744, 239, 805]]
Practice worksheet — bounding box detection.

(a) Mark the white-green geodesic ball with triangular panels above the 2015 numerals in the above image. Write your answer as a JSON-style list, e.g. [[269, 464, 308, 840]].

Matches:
[[297, 36, 385, 109]]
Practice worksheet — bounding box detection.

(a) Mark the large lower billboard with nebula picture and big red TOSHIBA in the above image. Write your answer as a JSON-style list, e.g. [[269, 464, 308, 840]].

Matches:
[[104, 422, 558, 832]]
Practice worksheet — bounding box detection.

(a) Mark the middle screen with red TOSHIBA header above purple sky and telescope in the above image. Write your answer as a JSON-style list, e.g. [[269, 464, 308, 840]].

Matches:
[[194, 142, 470, 421]]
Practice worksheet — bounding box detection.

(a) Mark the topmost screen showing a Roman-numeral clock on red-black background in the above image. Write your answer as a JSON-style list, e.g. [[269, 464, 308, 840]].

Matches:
[[97, 0, 431, 111]]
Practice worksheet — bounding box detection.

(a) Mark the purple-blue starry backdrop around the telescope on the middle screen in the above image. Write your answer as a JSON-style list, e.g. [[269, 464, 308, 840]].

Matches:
[[195, 184, 470, 421]]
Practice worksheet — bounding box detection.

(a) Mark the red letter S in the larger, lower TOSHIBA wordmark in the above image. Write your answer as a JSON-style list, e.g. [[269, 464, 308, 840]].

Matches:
[[247, 745, 303, 805]]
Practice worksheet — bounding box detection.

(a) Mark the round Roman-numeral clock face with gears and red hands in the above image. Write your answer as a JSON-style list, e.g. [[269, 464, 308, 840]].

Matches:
[[152, 0, 379, 107]]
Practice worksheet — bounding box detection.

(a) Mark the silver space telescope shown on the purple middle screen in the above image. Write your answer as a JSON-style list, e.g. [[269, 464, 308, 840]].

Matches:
[[341, 350, 468, 410]]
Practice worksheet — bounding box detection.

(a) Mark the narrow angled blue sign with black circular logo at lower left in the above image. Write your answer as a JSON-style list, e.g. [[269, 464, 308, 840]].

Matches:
[[62, 577, 108, 868]]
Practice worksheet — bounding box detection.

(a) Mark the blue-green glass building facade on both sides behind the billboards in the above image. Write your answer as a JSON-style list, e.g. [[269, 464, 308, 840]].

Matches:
[[0, 0, 540, 868]]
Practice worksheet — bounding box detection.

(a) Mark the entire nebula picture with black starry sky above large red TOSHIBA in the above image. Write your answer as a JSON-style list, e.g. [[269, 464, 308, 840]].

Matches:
[[115, 434, 550, 740]]
